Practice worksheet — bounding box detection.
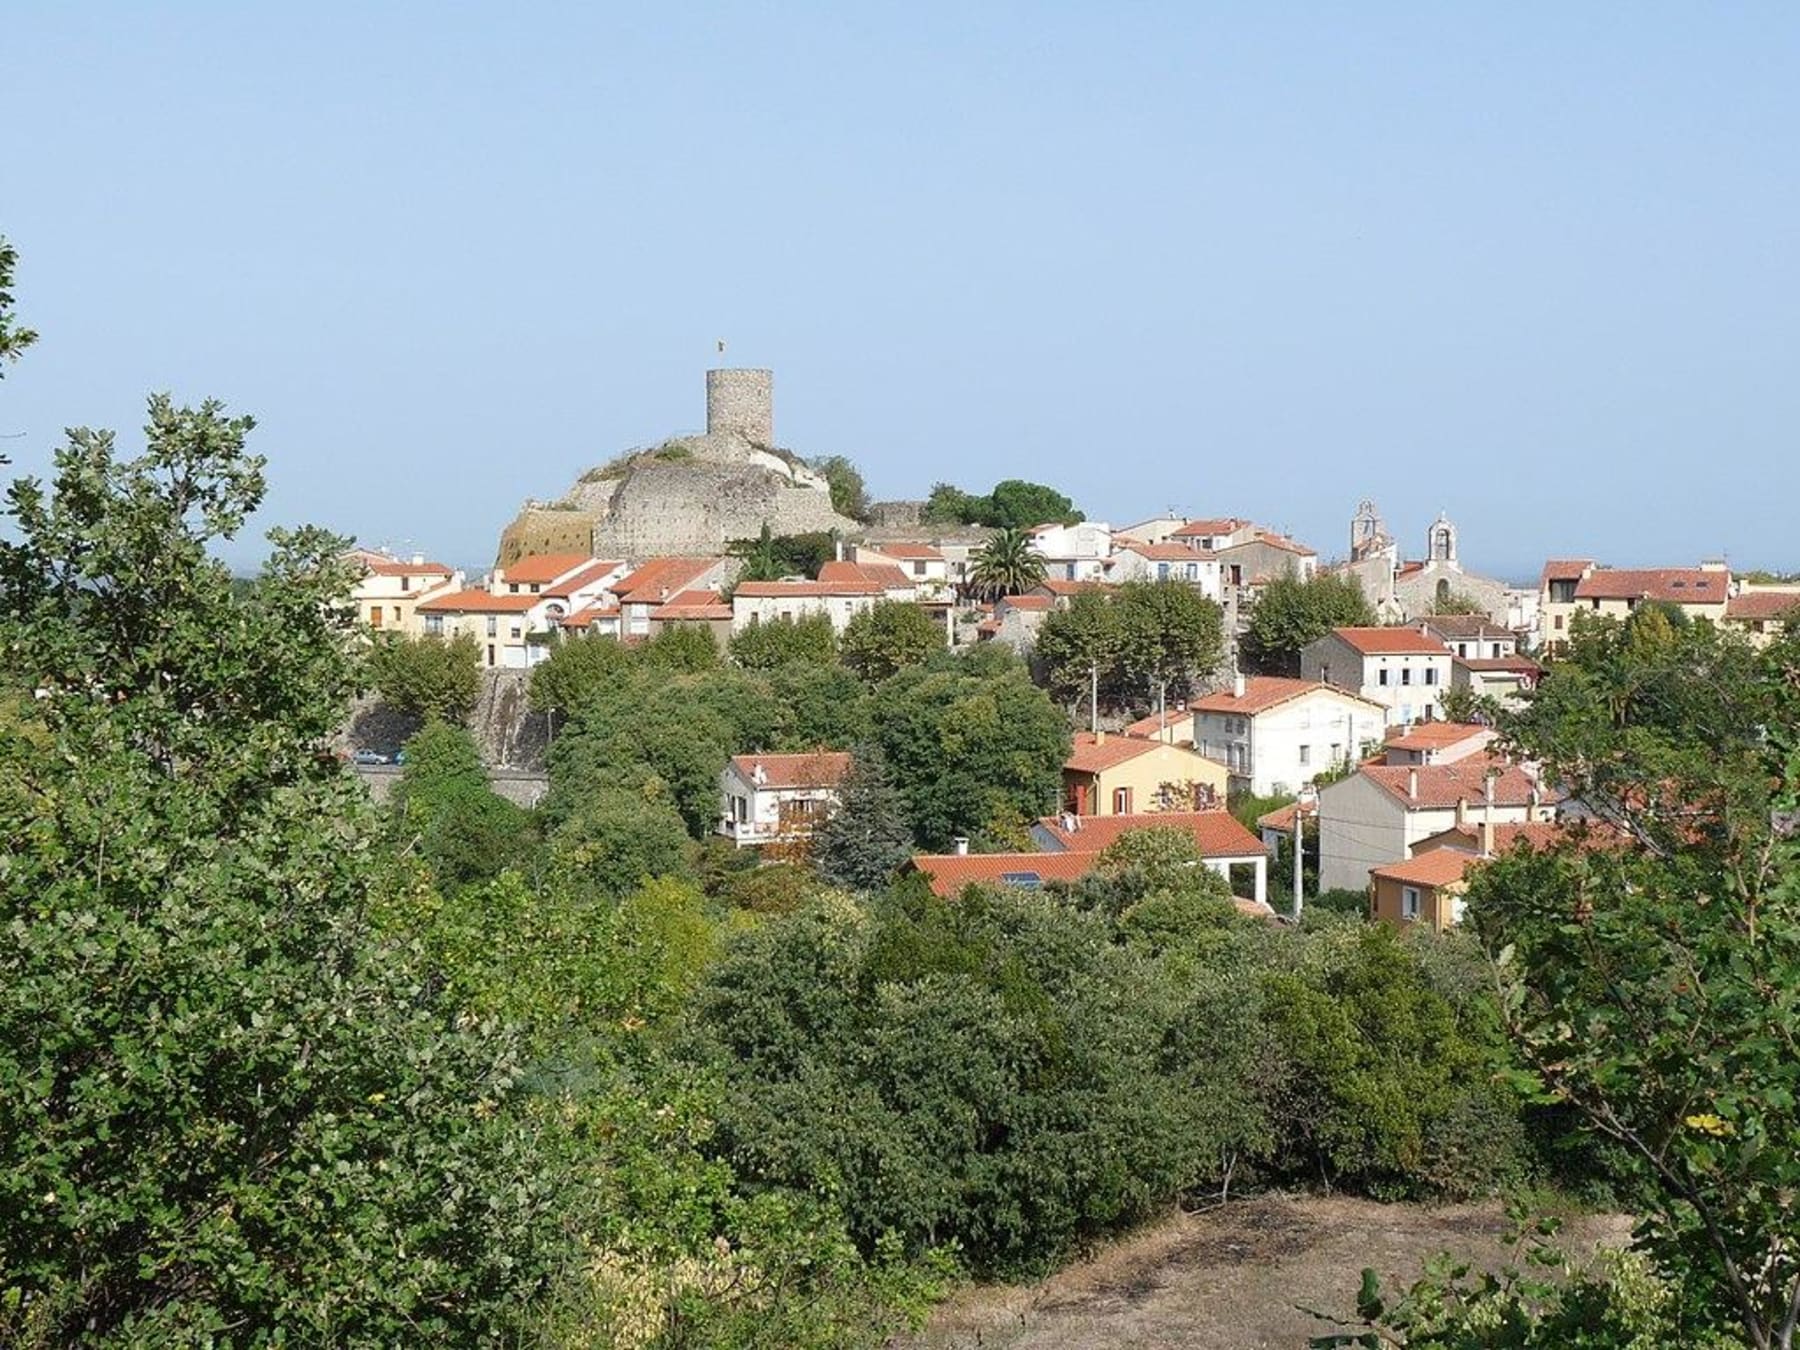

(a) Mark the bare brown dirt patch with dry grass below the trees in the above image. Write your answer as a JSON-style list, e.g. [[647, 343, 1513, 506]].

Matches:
[[905, 1195, 1629, 1350]]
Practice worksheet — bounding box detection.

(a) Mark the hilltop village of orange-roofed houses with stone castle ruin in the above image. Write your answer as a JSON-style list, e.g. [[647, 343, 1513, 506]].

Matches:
[[353, 369, 1800, 929]]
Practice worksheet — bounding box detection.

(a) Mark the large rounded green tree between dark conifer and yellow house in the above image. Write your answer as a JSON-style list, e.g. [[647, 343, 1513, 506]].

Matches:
[[871, 652, 1069, 848]]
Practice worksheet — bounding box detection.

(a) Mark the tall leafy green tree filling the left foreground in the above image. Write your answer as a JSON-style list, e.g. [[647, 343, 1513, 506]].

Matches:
[[0, 398, 572, 1346]]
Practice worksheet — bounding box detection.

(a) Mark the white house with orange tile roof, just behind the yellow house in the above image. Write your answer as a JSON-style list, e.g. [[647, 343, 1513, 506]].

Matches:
[[1192, 675, 1388, 796]]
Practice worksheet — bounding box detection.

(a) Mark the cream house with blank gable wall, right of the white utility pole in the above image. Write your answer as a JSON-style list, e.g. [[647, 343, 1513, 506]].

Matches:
[[1318, 754, 1555, 891]]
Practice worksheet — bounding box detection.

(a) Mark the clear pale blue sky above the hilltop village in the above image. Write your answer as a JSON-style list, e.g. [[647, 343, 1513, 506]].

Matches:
[[0, 0, 1800, 574]]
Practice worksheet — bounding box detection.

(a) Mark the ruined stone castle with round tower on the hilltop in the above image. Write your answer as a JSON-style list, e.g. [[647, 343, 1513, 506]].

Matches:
[[499, 369, 859, 567]]
